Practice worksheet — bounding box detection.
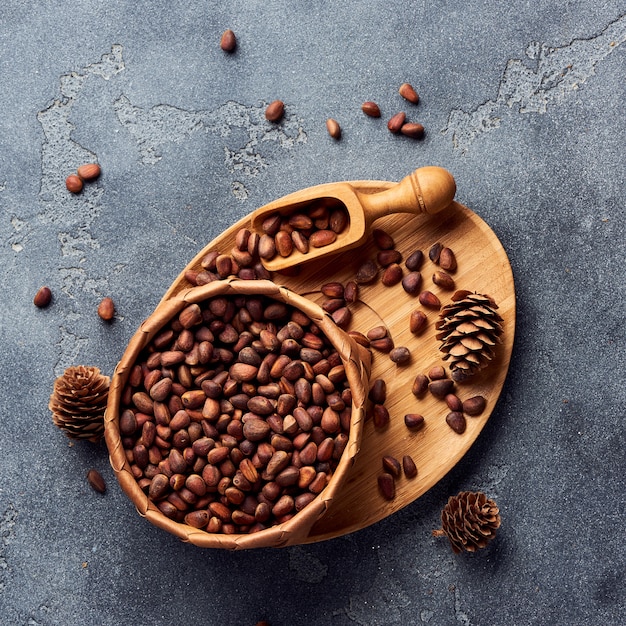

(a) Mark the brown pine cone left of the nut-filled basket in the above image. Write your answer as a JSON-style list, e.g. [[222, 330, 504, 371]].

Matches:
[[48, 365, 109, 442]]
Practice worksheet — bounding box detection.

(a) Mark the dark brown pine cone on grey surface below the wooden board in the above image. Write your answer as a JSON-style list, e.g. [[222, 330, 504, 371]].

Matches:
[[432, 491, 500, 554]]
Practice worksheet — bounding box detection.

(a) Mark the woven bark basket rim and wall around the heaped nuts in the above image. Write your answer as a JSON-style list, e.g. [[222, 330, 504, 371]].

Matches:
[[105, 278, 370, 550]]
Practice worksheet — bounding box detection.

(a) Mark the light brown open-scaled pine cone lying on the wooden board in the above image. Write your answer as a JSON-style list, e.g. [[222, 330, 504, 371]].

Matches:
[[435, 290, 503, 382]]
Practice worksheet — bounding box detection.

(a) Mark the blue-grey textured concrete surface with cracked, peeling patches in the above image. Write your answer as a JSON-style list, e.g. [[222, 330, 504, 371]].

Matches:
[[0, 0, 626, 626]]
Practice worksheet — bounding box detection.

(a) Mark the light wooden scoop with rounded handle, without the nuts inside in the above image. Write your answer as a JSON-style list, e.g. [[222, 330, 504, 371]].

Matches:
[[251, 166, 456, 271]]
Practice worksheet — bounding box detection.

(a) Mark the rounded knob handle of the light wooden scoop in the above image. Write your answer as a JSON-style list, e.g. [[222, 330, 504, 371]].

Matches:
[[357, 165, 456, 223]]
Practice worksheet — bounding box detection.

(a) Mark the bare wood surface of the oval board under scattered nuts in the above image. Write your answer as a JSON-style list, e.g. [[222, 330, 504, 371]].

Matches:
[[157, 181, 515, 543]]
